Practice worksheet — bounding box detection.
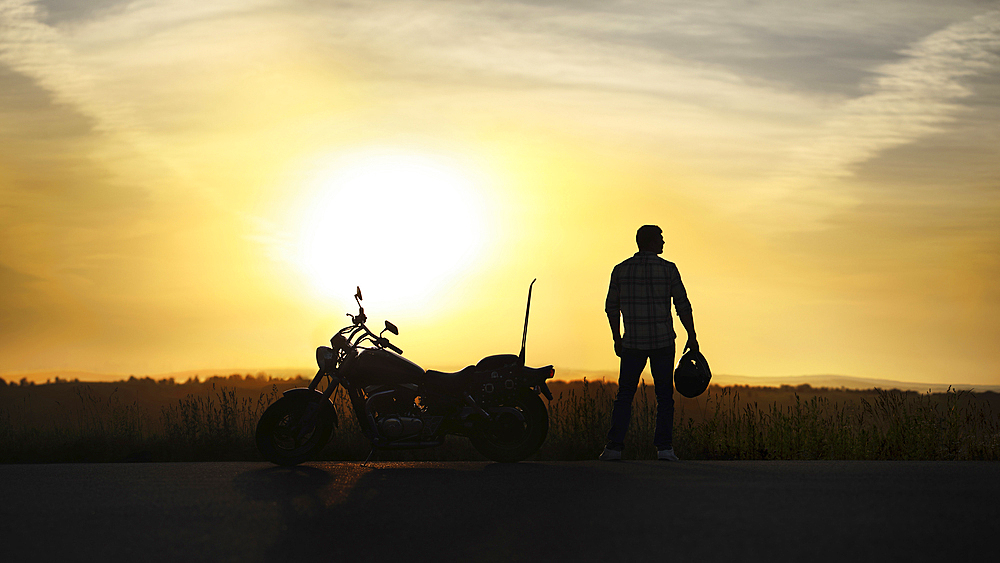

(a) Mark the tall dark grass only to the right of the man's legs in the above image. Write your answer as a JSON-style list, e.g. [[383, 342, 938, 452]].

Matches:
[[674, 388, 1000, 460]]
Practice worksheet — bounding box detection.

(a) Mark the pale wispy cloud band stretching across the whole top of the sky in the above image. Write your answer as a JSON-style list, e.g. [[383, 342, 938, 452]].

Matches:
[[0, 0, 998, 189]]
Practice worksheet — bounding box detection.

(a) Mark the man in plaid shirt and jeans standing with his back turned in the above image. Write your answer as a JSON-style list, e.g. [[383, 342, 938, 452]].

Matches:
[[601, 225, 698, 461]]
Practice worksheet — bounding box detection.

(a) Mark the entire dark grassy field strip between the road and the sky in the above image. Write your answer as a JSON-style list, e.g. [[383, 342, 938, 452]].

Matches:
[[0, 374, 1000, 463]]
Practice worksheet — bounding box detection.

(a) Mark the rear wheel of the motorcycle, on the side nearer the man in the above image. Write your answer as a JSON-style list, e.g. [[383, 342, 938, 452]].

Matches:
[[469, 393, 549, 463]]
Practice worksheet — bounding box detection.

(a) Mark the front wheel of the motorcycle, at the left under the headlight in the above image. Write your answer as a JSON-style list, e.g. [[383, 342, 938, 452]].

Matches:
[[256, 396, 334, 465]]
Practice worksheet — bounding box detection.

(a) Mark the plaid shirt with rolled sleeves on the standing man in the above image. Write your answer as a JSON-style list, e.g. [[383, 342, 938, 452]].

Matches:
[[604, 252, 691, 350]]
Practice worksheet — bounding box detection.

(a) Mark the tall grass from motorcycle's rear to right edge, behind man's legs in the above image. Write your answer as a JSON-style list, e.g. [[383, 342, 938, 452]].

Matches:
[[540, 381, 1000, 460]]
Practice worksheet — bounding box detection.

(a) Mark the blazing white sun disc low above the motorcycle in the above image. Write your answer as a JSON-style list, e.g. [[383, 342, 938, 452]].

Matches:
[[297, 152, 487, 310]]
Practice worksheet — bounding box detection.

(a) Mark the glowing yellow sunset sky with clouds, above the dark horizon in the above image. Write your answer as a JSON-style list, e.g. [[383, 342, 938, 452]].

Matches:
[[0, 0, 1000, 385]]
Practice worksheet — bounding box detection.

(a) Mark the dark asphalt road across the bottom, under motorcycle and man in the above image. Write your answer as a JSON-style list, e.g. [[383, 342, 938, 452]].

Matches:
[[0, 461, 1000, 563]]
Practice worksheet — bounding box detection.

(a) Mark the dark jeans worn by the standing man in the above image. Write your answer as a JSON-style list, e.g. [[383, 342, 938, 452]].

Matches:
[[608, 343, 674, 450]]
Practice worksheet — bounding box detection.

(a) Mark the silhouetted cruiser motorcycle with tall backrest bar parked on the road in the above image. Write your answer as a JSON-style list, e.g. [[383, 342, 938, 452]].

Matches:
[[256, 280, 555, 465]]
